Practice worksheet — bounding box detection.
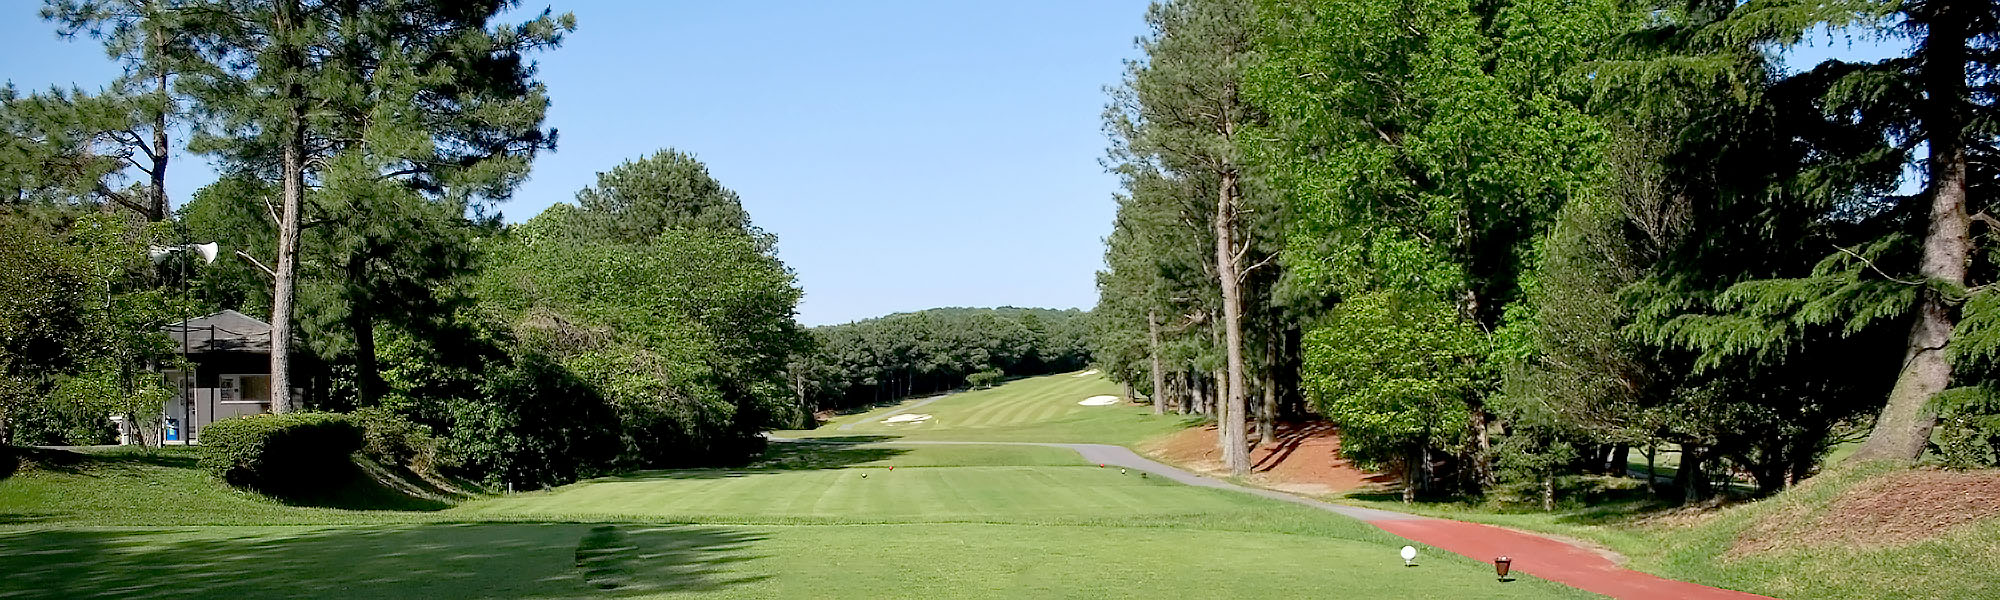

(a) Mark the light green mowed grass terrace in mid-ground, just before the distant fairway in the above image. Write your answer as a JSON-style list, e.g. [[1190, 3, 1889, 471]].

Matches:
[[454, 444, 1280, 524]]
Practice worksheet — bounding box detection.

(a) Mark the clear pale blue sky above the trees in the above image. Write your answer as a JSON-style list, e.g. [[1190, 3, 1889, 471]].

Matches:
[[0, 0, 1146, 324]]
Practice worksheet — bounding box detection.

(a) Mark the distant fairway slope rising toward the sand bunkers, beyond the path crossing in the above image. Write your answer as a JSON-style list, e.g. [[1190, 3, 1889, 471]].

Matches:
[[780, 372, 1198, 446]]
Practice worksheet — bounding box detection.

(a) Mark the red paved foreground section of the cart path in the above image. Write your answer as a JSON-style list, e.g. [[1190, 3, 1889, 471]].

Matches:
[[1368, 518, 1770, 600]]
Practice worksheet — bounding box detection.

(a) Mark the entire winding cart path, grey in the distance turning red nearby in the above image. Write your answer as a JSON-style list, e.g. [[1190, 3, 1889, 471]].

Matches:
[[770, 436, 1768, 600]]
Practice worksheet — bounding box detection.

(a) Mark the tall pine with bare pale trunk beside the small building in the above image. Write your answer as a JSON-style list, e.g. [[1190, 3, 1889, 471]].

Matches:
[[174, 0, 574, 412]]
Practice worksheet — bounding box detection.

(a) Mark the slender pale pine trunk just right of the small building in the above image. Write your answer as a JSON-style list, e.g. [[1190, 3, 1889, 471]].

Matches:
[[270, 2, 306, 412]]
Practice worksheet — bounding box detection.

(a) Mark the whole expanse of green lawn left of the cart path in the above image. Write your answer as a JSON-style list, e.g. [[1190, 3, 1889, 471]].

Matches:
[[0, 376, 1590, 600]]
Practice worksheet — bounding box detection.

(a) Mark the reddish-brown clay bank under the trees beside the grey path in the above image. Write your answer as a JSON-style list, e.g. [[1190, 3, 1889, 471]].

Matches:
[[1146, 422, 1394, 494]]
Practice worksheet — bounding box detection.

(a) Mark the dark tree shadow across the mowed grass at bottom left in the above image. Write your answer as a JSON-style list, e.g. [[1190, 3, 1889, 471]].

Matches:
[[0, 524, 768, 600]]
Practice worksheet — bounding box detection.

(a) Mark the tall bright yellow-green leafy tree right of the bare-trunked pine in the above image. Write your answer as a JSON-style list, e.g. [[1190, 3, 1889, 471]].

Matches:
[[1244, 0, 1618, 490]]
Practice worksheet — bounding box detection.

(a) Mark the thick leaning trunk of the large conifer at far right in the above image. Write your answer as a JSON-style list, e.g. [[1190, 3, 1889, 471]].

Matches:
[[1852, 4, 1972, 462]]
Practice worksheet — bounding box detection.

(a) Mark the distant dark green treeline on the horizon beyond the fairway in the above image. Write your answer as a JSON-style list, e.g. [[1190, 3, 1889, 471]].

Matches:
[[792, 306, 1090, 410]]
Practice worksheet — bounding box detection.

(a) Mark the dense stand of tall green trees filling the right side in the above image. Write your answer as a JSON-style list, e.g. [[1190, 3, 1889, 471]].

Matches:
[[1092, 0, 2000, 500]]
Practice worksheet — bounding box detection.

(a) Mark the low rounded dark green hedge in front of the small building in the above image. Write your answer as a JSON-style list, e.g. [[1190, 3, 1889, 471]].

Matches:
[[200, 412, 362, 496]]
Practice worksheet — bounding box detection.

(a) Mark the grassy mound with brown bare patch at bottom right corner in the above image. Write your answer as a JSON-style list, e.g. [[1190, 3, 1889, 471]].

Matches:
[[1636, 464, 2000, 598]]
